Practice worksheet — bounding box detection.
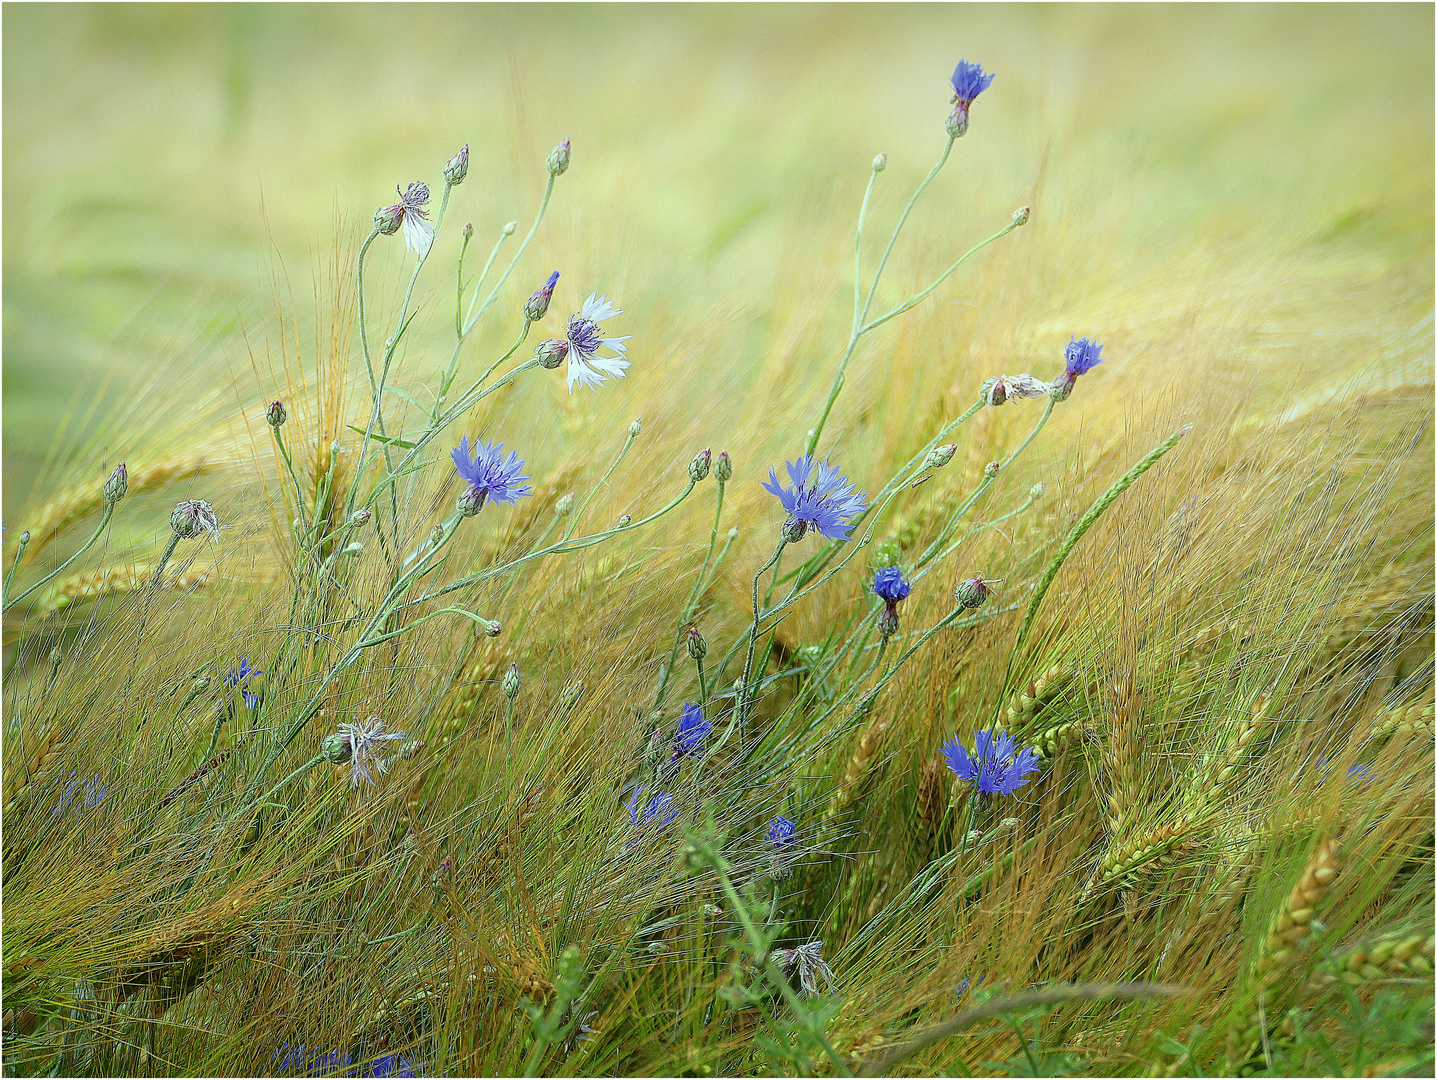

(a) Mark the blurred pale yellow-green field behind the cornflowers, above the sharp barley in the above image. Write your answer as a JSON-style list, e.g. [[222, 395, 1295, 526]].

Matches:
[[4, 4, 1433, 496]]
